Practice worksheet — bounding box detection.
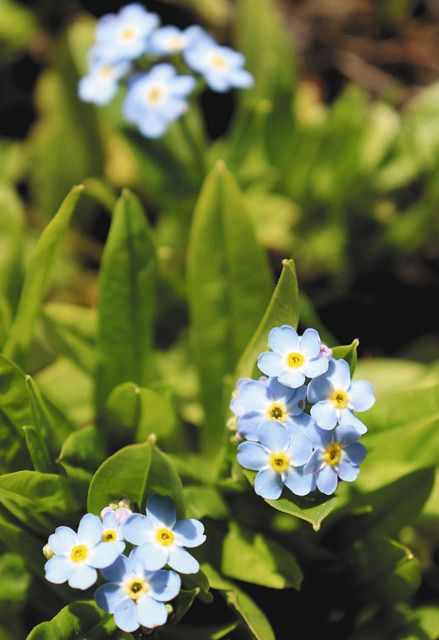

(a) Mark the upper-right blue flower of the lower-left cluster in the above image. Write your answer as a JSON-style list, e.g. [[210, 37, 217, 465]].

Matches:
[[124, 495, 206, 573]]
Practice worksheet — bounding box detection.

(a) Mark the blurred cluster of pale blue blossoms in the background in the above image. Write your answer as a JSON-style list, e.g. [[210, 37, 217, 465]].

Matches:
[[79, 3, 253, 138]]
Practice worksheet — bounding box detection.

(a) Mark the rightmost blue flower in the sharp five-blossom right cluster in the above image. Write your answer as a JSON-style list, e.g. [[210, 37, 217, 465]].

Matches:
[[307, 360, 375, 433]]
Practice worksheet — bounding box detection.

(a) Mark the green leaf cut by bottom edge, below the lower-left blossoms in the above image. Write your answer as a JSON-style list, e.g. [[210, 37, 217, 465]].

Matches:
[[26, 600, 119, 640]]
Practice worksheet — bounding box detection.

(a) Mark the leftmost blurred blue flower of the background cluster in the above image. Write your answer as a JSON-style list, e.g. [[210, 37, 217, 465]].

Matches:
[[78, 60, 129, 105]]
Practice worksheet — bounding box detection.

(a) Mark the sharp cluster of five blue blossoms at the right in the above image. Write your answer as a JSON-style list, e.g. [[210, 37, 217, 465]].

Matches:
[[230, 325, 375, 500]]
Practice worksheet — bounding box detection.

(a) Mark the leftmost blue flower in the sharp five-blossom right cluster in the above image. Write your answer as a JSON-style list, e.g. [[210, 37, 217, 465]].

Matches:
[[230, 377, 306, 441]]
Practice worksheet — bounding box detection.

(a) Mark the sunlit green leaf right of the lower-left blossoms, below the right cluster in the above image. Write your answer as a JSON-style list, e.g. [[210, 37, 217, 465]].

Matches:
[[221, 522, 303, 589]]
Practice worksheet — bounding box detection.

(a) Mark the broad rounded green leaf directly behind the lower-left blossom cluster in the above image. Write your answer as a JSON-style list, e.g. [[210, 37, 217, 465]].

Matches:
[[88, 442, 184, 515]]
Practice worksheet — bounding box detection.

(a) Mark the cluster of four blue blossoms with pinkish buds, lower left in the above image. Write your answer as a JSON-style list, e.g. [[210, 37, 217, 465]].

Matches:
[[44, 495, 206, 632]]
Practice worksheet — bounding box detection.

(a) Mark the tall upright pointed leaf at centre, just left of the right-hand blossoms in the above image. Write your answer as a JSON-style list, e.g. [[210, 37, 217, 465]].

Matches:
[[188, 162, 271, 455]]
